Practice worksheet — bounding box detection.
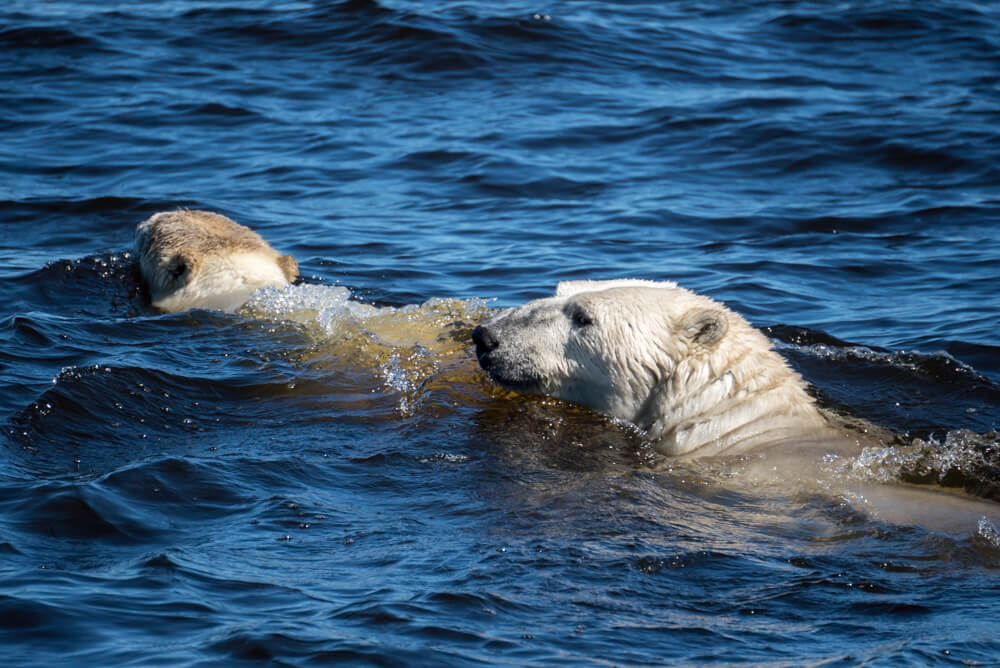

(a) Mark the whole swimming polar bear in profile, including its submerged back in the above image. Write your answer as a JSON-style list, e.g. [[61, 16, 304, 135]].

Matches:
[[472, 279, 1000, 542]]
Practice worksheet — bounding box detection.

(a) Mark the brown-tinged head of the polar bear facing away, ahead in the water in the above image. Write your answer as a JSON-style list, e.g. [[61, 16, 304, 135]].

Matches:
[[135, 209, 298, 312]]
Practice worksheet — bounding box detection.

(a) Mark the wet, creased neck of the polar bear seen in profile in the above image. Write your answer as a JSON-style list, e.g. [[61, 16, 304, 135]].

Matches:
[[636, 323, 831, 456]]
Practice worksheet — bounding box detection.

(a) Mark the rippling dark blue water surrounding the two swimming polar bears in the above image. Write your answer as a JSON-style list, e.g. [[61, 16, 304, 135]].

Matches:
[[0, 0, 1000, 666]]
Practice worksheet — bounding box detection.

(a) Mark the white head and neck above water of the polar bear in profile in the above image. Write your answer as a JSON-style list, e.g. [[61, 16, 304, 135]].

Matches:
[[472, 279, 857, 456]]
